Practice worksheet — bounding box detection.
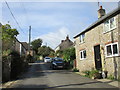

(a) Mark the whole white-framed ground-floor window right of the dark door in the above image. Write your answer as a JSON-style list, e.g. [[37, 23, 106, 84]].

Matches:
[[106, 43, 118, 57]]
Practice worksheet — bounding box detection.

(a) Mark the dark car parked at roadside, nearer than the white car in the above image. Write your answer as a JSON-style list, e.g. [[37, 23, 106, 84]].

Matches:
[[51, 58, 65, 69]]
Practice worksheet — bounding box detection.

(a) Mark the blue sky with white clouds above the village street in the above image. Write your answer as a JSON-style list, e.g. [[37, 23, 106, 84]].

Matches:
[[0, 0, 118, 49]]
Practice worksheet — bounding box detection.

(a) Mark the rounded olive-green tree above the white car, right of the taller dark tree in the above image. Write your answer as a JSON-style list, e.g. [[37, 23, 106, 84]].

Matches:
[[38, 46, 54, 57]]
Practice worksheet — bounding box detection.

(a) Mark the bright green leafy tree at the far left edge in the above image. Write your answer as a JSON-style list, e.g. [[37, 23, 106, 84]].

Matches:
[[2, 24, 19, 50]]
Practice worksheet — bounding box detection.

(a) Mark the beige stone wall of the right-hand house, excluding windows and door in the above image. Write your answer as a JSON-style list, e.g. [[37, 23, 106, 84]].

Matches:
[[75, 14, 120, 76]]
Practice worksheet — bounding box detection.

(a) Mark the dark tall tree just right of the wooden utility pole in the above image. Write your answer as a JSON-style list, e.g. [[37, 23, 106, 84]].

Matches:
[[31, 38, 42, 53]]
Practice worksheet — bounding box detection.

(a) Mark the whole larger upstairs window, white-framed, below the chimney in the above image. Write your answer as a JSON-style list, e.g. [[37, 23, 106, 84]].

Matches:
[[104, 17, 116, 32]]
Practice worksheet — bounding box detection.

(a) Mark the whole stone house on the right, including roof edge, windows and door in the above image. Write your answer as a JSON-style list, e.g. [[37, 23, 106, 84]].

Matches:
[[74, 7, 120, 78]]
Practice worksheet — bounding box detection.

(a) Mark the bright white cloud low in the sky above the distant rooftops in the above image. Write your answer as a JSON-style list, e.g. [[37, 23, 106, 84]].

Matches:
[[38, 27, 70, 49]]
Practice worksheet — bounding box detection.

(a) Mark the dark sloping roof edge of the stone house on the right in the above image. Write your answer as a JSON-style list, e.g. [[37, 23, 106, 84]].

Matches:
[[74, 6, 120, 38]]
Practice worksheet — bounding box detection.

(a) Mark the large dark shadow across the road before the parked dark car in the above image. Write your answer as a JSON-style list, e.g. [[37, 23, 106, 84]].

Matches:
[[19, 61, 71, 79]]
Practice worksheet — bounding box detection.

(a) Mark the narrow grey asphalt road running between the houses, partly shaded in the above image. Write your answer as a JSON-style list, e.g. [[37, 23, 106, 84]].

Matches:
[[10, 61, 118, 89]]
